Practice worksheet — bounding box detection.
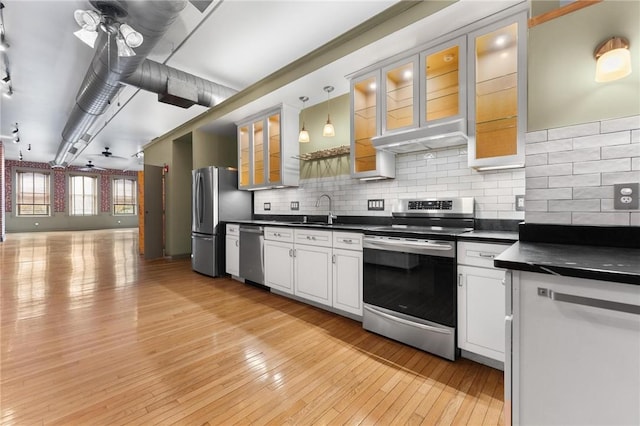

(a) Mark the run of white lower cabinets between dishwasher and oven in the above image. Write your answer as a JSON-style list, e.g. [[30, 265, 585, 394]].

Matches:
[[264, 227, 362, 317]]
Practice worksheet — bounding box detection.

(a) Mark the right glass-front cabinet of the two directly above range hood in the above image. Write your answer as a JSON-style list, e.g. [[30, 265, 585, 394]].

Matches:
[[420, 37, 467, 126]]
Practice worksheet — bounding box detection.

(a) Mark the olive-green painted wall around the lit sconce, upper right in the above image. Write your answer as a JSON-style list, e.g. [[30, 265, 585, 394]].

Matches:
[[528, 1, 640, 131]]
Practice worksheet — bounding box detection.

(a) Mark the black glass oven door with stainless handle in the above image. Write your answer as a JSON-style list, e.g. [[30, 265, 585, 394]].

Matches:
[[363, 235, 457, 328]]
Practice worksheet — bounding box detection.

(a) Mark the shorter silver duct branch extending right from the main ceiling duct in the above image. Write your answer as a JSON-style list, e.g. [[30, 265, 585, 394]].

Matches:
[[122, 59, 237, 107]]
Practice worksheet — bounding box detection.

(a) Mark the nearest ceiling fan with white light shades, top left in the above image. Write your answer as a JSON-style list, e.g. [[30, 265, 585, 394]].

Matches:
[[73, 2, 144, 56]]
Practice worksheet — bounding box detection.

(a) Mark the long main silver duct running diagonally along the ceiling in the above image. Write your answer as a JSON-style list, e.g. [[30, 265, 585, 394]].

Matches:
[[50, 0, 187, 167]]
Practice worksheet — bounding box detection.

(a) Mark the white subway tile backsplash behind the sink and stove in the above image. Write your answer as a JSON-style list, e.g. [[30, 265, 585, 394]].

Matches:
[[254, 148, 525, 220]]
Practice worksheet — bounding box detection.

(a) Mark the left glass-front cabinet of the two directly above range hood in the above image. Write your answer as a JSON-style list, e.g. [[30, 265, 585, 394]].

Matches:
[[382, 56, 419, 134]]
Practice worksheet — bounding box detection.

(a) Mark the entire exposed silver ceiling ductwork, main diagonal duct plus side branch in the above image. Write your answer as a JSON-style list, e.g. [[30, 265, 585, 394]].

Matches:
[[50, 0, 235, 167]]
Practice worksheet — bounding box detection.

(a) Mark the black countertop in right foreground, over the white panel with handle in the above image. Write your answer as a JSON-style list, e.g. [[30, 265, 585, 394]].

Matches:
[[494, 241, 640, 285]]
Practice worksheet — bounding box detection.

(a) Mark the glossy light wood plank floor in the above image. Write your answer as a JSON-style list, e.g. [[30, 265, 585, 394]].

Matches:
[[0, 230, 503, 425]]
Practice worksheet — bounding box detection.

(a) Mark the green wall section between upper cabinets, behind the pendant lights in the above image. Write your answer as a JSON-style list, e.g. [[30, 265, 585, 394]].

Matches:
[[300, 93, 351, 179]]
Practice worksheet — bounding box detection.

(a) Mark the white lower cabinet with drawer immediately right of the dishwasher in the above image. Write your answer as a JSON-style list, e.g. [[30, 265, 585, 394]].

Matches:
[[264, 227, 294, 294]]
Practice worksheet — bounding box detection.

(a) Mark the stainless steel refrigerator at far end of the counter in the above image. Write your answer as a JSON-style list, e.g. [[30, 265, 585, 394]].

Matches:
[[191, 167, 252, 277]]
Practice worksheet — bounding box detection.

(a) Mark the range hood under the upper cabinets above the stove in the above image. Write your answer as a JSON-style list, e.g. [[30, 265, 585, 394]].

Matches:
[[371, 118, 467, 154]]
